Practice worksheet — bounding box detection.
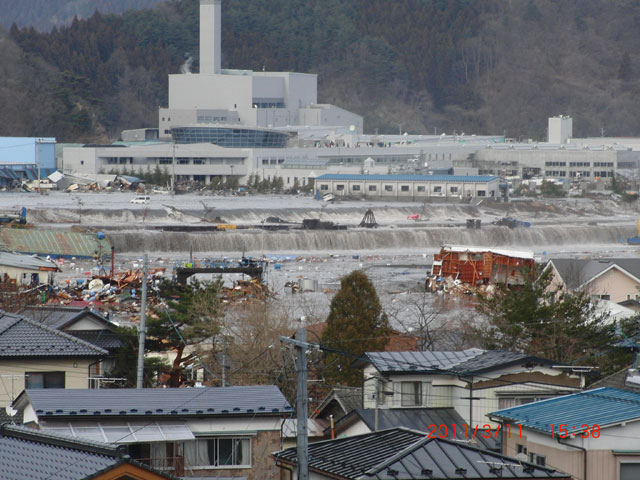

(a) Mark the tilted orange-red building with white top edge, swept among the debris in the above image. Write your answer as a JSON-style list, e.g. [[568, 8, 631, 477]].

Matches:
[[432, 245, 535, 285]]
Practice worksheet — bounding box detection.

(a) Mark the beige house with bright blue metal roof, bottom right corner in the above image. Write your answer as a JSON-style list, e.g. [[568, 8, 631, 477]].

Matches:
[[489, 388, 640, 480]]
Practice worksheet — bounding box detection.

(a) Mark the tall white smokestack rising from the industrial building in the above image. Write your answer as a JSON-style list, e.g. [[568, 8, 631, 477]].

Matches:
[[200, 0, 222, 73]]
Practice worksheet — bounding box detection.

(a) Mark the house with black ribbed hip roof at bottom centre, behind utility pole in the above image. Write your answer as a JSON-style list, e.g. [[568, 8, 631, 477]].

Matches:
[[273, 428, 571, 480]]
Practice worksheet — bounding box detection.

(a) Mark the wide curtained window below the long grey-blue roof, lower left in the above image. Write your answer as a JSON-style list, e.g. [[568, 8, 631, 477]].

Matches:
[[184, 437, 251, 468]]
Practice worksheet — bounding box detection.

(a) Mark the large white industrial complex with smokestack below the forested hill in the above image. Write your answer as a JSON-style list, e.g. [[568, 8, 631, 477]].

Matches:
[[60, 0, 640, 191]]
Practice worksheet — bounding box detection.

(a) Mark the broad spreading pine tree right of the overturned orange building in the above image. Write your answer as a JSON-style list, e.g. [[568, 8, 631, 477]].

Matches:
[[476, 269, 613, 365]]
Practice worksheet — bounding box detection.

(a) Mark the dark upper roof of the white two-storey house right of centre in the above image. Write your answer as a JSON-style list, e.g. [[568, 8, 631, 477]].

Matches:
[[355, 348, 554, 375]]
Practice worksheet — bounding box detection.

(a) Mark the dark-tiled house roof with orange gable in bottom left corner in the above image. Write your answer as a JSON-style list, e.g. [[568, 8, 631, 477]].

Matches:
[[0, 424, 177, 480]]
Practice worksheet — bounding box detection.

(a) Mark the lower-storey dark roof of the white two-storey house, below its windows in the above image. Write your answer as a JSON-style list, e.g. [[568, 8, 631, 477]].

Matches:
[[352, 407, 499, 450]]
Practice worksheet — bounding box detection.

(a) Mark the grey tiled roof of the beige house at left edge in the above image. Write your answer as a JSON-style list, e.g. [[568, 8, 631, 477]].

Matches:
[[0, 312, 108, 358]]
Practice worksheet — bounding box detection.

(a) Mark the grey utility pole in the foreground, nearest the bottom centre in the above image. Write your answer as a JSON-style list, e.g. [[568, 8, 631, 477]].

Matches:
[[280, 324, 315, 480]]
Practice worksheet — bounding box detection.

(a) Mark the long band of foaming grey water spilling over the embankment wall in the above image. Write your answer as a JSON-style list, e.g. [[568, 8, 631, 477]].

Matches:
[[114, 225, 634, 253]]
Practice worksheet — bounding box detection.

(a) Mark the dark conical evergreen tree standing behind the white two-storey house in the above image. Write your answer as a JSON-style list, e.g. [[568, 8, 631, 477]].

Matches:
[[322, 270, 390, 386]]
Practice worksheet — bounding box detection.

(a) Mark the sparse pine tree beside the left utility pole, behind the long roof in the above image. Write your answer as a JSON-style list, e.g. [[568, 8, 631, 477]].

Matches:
[[147, 280, 222, 387]]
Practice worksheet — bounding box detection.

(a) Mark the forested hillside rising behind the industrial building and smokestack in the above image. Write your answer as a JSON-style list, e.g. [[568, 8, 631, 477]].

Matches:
[[0, 0, 640, 141]]
